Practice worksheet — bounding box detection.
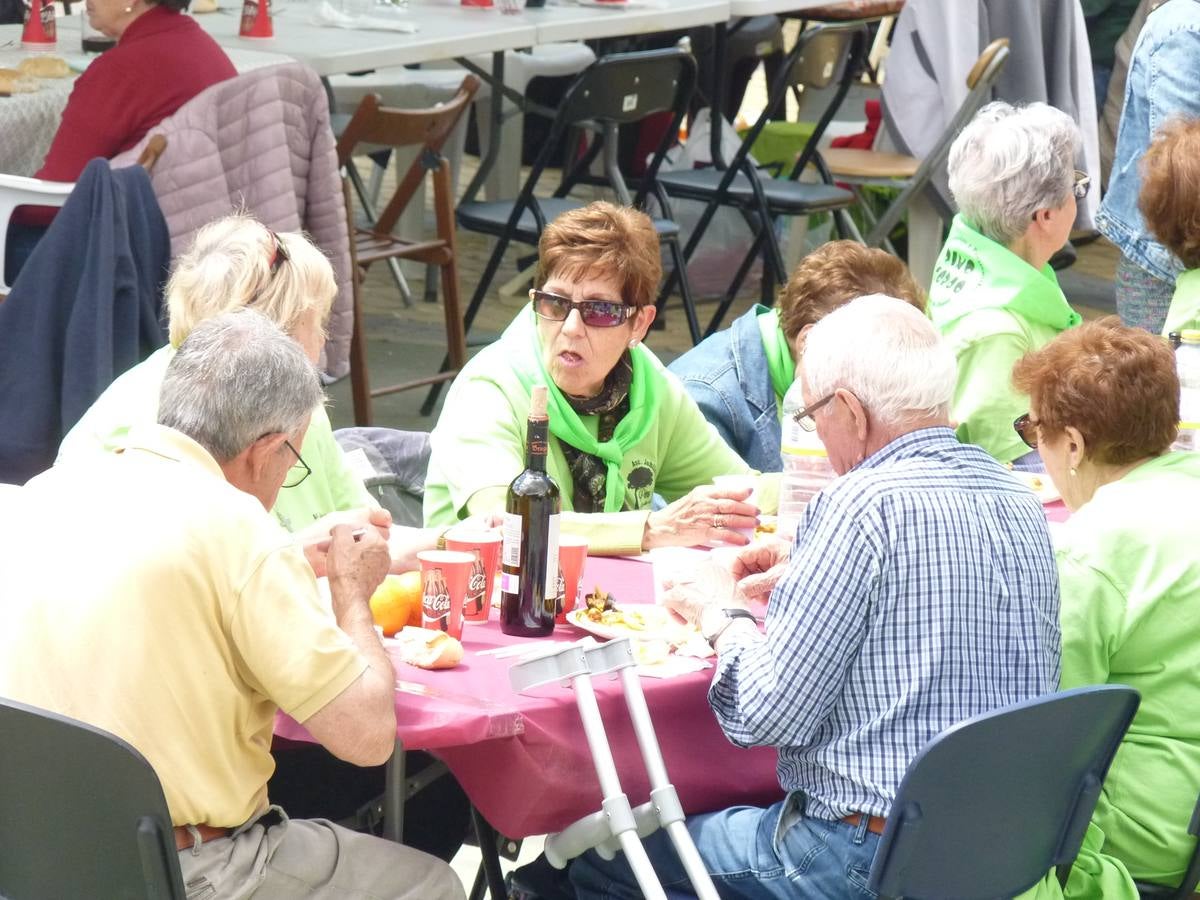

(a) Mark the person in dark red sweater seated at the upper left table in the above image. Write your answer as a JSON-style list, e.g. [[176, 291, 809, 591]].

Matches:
[[5, 0, 238, 284]]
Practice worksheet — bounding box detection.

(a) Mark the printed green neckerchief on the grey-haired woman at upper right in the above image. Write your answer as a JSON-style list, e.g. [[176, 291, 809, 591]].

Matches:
[[929, 216, 1081, 331]]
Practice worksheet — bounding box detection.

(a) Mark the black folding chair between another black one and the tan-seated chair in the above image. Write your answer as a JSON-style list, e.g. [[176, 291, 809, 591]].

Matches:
[[659, 22, 868, 335]]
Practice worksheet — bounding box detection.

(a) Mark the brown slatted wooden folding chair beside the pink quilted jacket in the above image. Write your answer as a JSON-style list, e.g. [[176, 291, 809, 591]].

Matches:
[[337, 76, 479, 425]]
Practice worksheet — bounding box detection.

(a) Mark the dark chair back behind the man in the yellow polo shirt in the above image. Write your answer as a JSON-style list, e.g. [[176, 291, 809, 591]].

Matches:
[[0, 698, 184, 900]]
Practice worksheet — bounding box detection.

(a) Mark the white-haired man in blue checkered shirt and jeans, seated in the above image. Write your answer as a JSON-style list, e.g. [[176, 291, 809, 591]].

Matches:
[[571, 296, 1060, 900]]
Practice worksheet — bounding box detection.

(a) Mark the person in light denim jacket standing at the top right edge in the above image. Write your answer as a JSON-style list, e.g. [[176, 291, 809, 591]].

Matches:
[[1096, 0, 1200, 334]]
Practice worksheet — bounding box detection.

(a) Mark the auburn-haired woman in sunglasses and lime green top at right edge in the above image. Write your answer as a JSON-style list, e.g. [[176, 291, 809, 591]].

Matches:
[[1013, 317, 1200, 896]]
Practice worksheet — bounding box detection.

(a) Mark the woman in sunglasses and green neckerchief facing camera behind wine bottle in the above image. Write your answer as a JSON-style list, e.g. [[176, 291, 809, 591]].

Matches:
[[425, 203, 757, 553]]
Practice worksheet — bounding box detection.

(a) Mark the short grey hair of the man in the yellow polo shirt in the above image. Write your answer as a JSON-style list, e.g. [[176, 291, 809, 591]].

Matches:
[[158, 310, 325, 463]]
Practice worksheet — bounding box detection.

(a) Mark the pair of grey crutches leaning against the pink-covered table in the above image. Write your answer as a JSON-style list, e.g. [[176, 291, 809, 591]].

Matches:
[[509, 638, 718, 900]]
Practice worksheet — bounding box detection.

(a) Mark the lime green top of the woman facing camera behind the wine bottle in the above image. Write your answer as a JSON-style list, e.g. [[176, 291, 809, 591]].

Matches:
[[425, 311, 751, 554]]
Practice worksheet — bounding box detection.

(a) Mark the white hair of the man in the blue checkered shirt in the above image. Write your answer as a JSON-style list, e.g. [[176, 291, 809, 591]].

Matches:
[[800, 294, 956, 426]]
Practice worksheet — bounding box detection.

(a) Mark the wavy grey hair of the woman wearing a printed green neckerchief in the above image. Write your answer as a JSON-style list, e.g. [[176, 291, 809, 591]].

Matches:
[[948, 101, 1082, 246]]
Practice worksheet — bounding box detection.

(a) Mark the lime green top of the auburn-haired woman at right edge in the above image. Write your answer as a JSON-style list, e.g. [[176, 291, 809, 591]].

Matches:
[[1055, 452, 1200, 884]]
